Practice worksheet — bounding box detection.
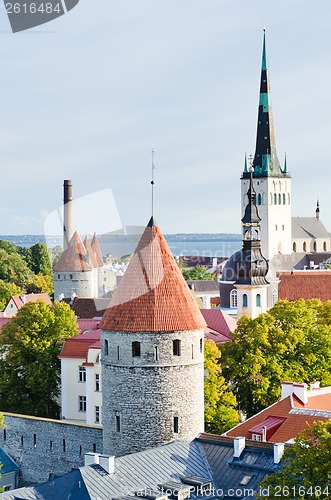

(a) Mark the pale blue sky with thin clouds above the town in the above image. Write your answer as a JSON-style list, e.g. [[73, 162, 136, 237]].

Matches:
[[0, 0, 331, 235]]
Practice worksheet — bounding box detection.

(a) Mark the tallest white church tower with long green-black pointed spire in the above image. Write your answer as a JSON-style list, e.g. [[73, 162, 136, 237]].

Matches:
[[241, 32, 292, 260]]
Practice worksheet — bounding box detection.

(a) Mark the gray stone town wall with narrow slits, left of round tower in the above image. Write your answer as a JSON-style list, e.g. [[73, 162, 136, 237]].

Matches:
[[0, 413, 103, 483]]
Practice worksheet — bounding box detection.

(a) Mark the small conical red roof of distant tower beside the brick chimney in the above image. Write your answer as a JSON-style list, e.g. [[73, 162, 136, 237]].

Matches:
[[54, 231, 92, 272]]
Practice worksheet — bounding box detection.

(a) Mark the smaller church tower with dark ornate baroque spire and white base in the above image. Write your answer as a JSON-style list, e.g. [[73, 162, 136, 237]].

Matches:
[[234, 167, 269, 318]]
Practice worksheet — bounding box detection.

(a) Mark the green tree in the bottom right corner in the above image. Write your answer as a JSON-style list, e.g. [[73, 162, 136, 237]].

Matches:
[[257, 420, 331, 500]]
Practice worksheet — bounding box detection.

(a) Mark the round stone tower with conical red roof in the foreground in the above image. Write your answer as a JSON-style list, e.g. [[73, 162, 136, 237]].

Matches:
[[101, 218, 205, 455]]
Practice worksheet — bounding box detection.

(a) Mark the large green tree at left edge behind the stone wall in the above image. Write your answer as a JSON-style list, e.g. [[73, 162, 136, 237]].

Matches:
[[0, 300, 78, 418]]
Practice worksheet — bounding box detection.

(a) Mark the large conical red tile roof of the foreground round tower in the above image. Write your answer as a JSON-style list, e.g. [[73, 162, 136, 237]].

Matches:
[[100, 218, 206, 332]]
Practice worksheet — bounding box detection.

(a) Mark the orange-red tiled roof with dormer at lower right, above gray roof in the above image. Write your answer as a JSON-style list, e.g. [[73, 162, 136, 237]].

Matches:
[[225, 389, 331, 443]]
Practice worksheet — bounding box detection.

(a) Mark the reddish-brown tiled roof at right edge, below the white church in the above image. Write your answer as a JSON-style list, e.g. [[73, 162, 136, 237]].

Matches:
[[278, 270, 331, 302]]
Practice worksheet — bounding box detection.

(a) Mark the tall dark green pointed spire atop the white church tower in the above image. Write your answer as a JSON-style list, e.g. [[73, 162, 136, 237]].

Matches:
[[252, 29, 284, 177]]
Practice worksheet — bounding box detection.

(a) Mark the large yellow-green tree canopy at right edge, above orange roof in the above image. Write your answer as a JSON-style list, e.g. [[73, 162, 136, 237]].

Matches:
[[222, 299, 331, 417]]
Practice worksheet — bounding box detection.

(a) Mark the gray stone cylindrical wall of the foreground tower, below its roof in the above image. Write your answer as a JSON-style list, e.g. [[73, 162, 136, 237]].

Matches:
[[101, 330, 204, 455]]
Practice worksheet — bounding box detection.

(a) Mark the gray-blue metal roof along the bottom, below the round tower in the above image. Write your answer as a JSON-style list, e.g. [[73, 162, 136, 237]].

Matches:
[[0, 435, 279, 500]]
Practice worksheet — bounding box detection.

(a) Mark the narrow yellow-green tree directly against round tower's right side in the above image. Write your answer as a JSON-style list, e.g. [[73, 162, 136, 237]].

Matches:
[[204, 340, 239, 434]]
